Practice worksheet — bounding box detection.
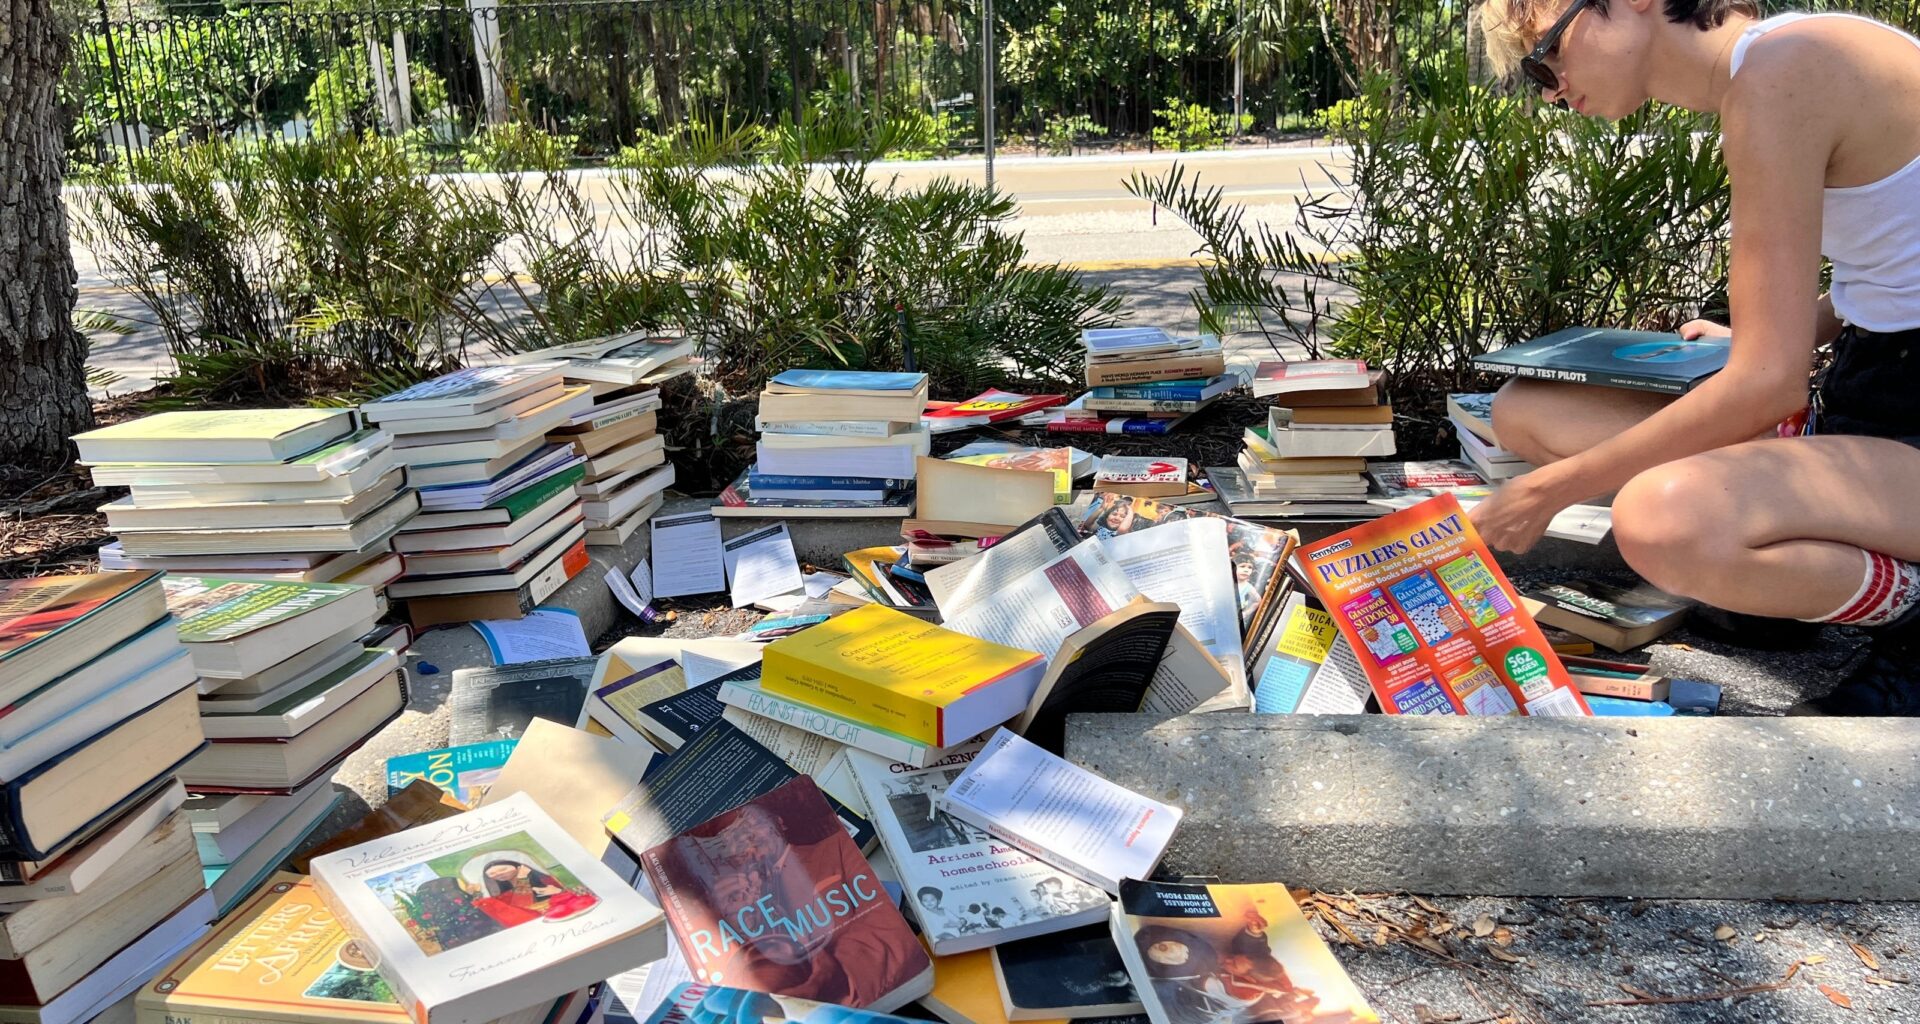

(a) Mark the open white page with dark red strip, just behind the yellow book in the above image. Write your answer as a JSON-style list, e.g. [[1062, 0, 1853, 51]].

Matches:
[[947, 540, 1140, 657]]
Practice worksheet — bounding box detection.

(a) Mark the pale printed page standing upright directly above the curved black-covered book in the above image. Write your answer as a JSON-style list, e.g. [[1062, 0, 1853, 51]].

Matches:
[[1102, 519, 1246, 678]]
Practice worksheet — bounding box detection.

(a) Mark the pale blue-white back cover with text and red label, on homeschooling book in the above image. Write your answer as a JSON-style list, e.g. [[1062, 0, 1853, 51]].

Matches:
[[941, 728, 1183, 893]]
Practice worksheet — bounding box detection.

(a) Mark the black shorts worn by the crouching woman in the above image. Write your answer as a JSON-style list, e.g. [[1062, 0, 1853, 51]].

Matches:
[[1812, 327, 1920, 448]]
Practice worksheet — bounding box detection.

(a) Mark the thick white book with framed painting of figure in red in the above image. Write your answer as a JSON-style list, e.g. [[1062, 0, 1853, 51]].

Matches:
[[313, 793, 666, 1024]]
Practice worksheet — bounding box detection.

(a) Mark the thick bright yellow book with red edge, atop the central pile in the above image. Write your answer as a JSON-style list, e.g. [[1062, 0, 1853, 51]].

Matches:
[[760, 605, 1046, 747]]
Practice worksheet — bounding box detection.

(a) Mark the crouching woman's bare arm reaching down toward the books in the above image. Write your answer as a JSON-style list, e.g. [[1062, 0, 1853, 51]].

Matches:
[[1473, 37, 1839, 551]]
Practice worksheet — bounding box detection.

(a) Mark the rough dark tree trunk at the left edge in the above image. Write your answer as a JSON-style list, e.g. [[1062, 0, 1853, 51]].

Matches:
[[0, 0, 94, 469]]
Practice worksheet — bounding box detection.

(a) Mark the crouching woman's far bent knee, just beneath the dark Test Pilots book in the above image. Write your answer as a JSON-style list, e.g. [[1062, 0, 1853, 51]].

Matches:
[[1494, 377, 1672, 465]]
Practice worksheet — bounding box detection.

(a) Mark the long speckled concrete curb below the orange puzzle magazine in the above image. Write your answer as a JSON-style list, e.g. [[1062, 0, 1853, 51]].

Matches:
[[1068, 713, 1920, 899]]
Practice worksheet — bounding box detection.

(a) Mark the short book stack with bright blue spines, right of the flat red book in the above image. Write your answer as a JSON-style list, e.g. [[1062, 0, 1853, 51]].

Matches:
[[1046, 327, 1240, 434]]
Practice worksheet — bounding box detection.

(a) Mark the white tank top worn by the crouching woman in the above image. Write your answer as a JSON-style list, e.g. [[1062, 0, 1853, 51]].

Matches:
[[1728, 13, 1920, 330]]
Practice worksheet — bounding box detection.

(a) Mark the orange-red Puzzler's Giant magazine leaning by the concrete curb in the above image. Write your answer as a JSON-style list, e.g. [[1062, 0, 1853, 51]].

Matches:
[[1300, 494, 1592, 715]]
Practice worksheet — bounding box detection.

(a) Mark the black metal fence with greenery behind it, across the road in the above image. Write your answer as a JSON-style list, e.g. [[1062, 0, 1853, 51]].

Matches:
[[63, 0, 1920, 173]]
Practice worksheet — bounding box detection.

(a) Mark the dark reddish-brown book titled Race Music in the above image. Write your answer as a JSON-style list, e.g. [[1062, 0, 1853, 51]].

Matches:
[[641, 776, 933, 1012]]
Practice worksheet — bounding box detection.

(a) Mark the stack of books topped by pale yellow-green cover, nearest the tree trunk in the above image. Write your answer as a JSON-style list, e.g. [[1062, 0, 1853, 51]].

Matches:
[[73, 409, 420, 588]]
